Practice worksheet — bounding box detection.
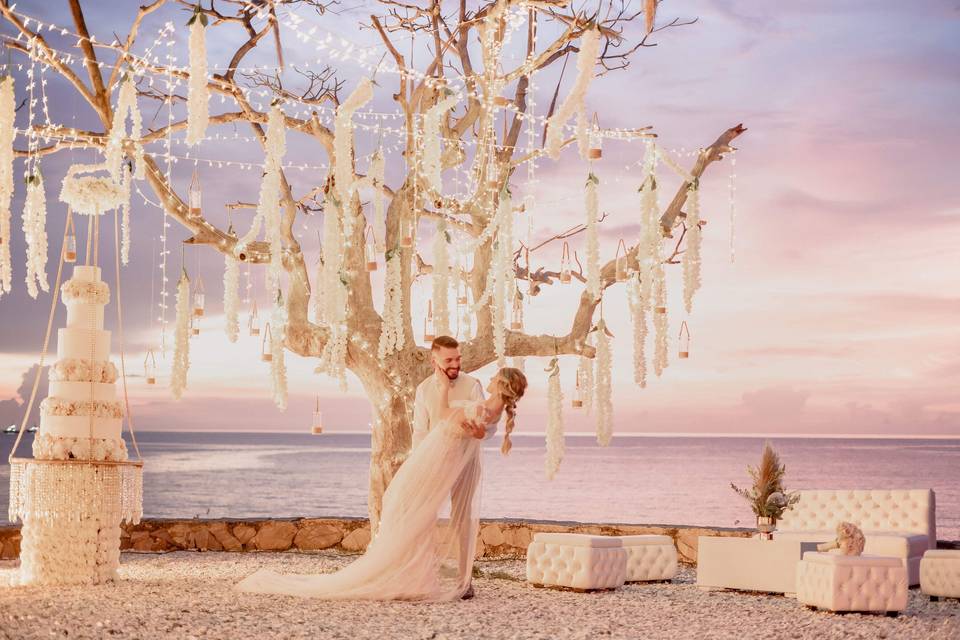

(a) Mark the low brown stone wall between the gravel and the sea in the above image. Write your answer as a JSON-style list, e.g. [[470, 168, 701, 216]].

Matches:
[[0, 518, 960, 564]]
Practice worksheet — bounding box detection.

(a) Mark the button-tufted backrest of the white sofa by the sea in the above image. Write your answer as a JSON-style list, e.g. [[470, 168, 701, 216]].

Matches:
[[777, 489, 937, 549]]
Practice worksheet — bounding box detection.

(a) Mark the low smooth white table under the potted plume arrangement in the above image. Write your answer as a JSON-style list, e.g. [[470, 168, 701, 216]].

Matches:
[[697, 534, 817, 597]]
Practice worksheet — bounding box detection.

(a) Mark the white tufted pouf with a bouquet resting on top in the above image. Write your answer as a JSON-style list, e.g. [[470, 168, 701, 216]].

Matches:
[[796, 551, 907, 615]]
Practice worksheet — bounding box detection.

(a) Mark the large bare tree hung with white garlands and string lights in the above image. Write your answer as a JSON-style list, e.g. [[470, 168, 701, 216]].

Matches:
[[0, 0, 744, 526]]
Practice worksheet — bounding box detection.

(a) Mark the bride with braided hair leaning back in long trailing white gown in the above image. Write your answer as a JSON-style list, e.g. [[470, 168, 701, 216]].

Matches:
[[236, 366, 527, 601]]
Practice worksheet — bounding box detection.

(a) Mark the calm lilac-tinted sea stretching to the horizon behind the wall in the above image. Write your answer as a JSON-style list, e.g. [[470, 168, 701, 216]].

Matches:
[[0, 431, 960, 540]]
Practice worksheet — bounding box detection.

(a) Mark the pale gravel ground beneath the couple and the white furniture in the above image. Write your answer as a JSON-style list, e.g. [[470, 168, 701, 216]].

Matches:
[[0, 551, 960, 640]]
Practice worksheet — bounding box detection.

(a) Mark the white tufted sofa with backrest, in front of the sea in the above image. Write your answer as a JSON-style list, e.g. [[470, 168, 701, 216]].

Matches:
[[774, 489, 937, 585]]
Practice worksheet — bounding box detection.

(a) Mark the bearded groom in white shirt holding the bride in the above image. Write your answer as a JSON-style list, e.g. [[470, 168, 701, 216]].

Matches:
[[413, 336, 488, 598]]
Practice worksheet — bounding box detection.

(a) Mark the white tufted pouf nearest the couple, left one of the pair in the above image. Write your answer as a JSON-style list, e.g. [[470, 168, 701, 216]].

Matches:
[[527, 533, 627, 591]]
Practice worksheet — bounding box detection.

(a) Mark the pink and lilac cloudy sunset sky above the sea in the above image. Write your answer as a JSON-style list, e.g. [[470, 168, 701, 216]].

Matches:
[[0, 0, 960, 436]]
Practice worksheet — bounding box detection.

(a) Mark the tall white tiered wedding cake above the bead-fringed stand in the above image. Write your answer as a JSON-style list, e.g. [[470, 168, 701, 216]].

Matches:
[[33, 266, 127, 461]]
